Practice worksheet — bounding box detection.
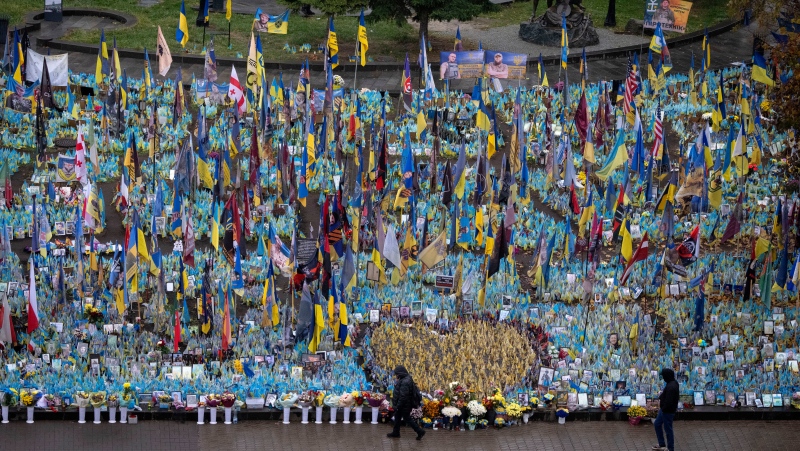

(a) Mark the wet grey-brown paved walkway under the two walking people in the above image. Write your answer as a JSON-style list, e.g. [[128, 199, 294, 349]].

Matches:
[[0, 421, 800, 451]]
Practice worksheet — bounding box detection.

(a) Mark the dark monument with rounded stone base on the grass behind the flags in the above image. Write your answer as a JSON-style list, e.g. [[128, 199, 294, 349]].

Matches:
[[519, 0, 600, 48]]
